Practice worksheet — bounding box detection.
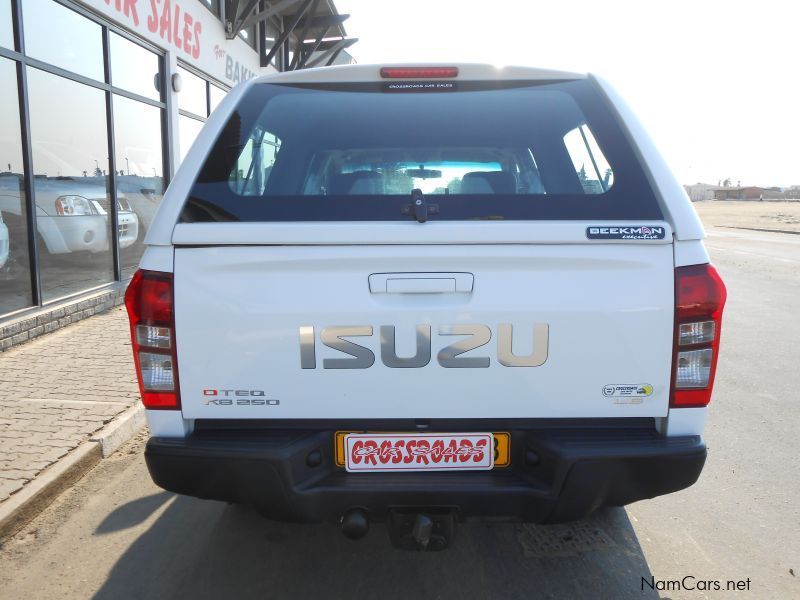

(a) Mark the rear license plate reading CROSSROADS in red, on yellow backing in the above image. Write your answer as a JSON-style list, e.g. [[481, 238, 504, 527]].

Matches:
[[335, 431, 510, 472]]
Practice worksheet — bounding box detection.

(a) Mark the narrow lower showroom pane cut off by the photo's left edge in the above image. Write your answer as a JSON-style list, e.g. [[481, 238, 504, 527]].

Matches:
[[0, 58, 33, 315]]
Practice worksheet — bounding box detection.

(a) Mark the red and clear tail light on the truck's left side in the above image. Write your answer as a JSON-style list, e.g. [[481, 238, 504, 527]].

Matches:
[[125, 269, 181, 409]]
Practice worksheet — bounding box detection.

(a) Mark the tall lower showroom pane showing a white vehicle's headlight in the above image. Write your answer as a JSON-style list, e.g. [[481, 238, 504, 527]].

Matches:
[[28, 67, 114, 302]]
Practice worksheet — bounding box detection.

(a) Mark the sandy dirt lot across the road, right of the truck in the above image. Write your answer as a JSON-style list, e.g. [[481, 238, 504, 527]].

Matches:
[[694, 200, 800, 234]]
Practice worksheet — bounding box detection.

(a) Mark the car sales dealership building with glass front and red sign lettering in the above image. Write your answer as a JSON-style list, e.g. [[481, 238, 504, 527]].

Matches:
[[0, 0, 356, 350]]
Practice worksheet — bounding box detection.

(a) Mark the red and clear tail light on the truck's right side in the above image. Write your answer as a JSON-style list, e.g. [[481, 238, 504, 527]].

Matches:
[[670, 264, 727, 408]]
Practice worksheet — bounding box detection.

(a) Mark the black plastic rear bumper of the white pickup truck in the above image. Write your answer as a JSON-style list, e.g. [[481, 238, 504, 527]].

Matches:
[[145, 428, 706, 522]]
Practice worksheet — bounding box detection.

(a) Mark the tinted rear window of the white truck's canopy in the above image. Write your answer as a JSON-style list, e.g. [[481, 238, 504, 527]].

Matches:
[[181, 81, 662, 222]]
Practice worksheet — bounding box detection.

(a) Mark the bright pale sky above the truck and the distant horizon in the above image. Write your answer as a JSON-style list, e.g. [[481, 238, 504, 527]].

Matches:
[[335, 0, 800, 187]]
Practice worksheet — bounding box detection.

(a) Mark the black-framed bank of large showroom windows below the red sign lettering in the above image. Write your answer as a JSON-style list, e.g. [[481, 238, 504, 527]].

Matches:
[[0, 0, 168, 319]]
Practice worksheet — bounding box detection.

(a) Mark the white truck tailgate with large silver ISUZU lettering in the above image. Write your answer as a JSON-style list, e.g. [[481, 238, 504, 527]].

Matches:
[[175, 237, 674, 419]]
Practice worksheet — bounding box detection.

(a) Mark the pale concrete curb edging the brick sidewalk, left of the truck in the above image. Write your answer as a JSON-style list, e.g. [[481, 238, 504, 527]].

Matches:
[[0, 402, 145, 540]]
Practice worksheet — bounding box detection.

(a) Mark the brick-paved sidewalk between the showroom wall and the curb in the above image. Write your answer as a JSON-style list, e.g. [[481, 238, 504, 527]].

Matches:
[[0, 307, 139, 502]]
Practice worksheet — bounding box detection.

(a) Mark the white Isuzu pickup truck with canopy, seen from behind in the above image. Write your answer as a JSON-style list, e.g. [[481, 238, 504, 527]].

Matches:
[[126, 64, 726, 550]]
